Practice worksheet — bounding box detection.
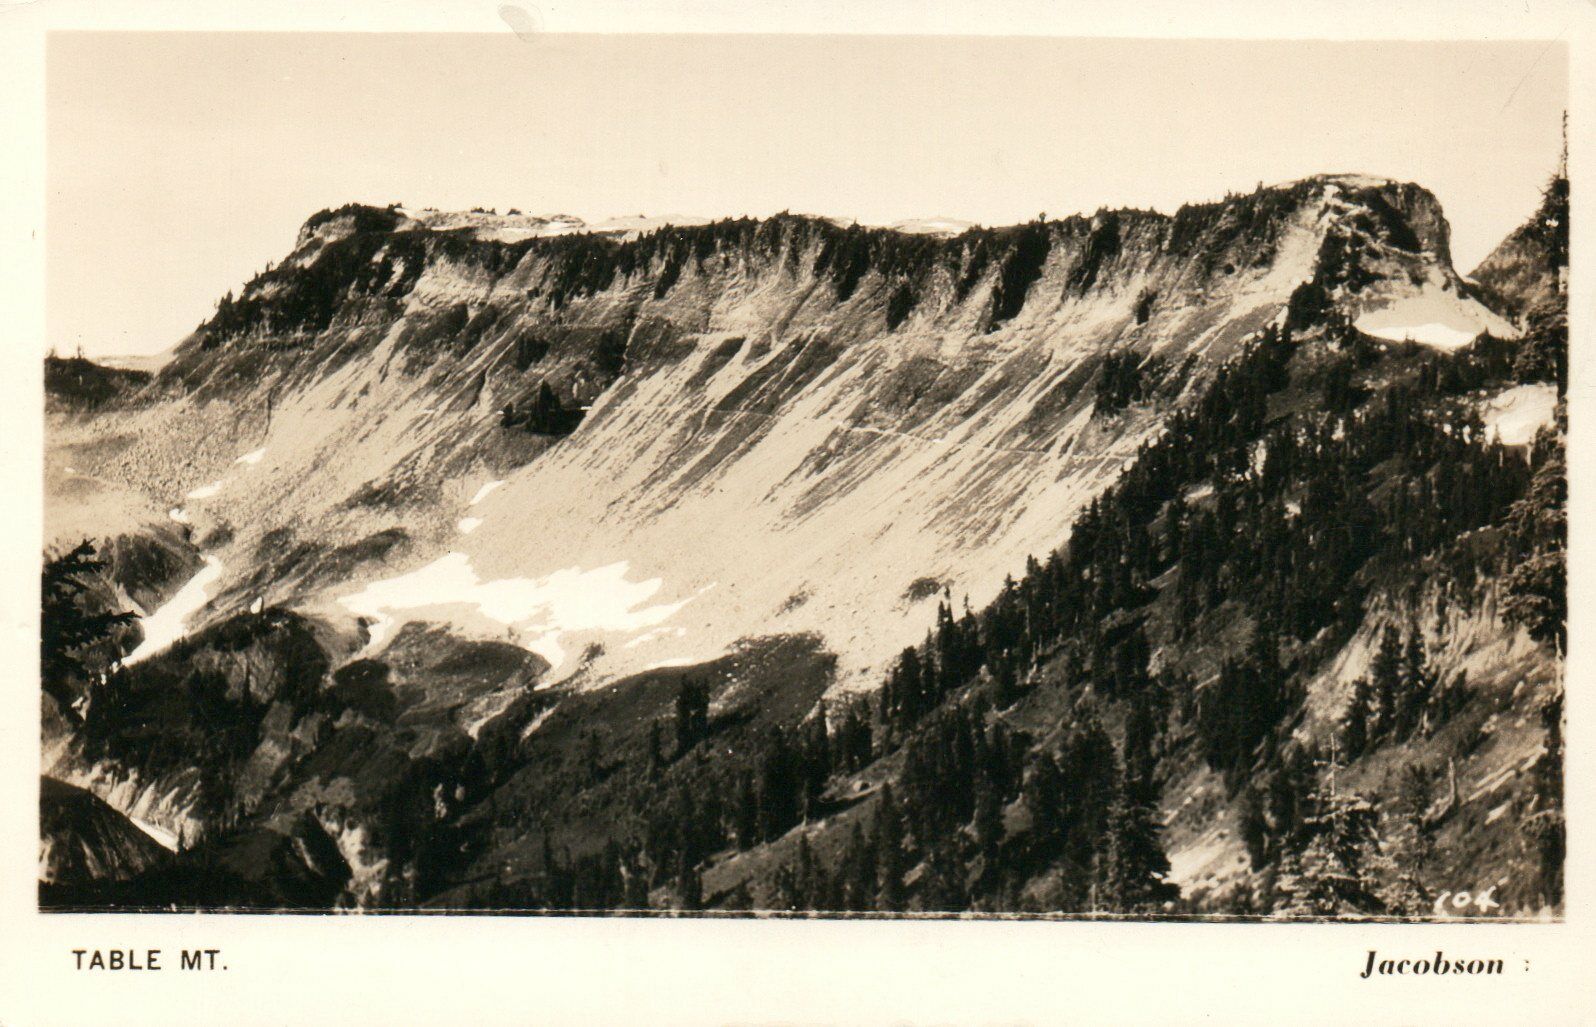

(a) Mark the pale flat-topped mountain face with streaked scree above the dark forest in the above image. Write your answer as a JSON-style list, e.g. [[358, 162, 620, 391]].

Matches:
[[53, 177, 1508, 680]]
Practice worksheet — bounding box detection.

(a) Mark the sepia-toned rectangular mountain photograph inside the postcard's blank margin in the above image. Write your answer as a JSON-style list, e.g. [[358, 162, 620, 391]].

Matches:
[[34, 24, 1570, 926]]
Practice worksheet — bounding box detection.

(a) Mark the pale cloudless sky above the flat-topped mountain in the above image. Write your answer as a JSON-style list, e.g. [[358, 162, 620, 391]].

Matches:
[[46, 32, 1567, 356]]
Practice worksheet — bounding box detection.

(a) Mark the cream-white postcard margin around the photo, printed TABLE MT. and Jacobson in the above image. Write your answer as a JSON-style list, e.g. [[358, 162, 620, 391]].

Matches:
[[0, 0, 1596, 1027]]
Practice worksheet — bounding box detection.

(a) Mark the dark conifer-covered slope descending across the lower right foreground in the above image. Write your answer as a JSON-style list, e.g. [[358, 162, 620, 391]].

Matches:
[[685, 303, 1566, 917]]
